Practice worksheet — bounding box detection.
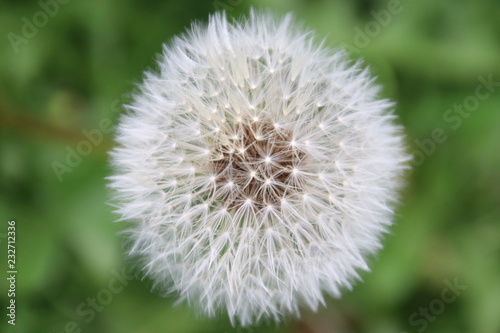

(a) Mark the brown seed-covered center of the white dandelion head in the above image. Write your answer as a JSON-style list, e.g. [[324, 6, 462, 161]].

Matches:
[[212, 119, 304, 211]]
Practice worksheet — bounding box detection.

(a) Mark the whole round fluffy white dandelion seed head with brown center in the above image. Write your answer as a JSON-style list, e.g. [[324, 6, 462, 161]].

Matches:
[[110, 12, 408, 326]]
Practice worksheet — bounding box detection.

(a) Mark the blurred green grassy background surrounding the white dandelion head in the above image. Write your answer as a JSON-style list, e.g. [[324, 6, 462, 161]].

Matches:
[[0, 0, 500, 333]]
